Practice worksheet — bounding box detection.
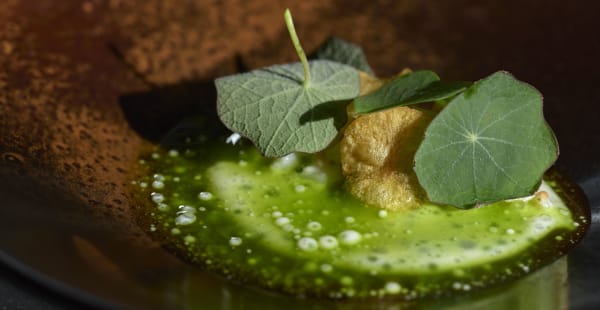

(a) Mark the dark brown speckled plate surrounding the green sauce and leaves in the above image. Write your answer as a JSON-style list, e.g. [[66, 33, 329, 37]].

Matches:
[[0, 0, 600, 309]]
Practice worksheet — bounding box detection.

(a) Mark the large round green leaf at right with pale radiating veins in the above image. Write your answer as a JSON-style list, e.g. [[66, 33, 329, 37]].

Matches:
[[415, 72, 558, 208]]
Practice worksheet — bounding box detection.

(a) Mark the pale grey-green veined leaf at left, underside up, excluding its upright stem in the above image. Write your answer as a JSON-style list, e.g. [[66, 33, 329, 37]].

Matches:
[[215, 60, 359, 157]]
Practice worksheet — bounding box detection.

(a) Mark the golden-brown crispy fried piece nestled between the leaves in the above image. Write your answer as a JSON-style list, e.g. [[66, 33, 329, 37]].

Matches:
[[340, 107, 434, 210]]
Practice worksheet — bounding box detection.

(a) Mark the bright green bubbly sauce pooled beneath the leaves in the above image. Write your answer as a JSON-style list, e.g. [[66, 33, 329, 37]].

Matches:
[[139, 139, 583, 299]]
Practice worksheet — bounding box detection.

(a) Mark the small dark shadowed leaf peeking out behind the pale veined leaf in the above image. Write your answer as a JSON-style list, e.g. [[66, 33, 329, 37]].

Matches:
[[311, 37, 373, 75]]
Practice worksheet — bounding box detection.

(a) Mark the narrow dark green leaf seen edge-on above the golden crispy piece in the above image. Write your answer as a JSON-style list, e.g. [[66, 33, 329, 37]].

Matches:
[[354, 70, 440, 114]]
